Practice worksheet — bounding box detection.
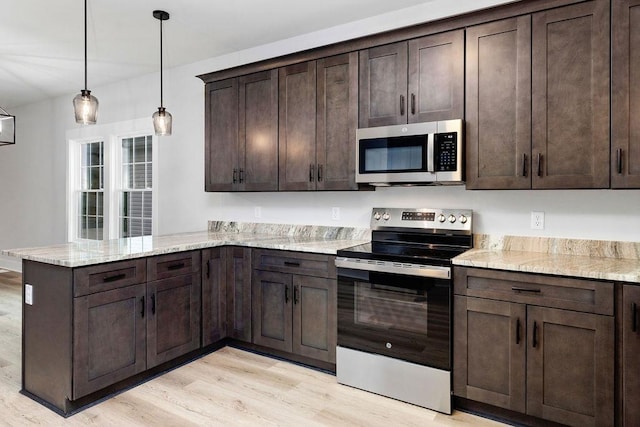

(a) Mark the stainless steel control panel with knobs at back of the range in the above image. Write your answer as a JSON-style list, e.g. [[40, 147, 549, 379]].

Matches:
[[371, 208, 473, 232]]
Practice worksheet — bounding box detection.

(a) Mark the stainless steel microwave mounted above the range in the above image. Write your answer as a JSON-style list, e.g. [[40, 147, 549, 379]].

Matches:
[[356, 119, 464, 185]]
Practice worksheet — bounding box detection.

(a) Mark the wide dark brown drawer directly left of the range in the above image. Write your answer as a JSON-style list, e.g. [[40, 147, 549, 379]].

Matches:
[[253, 250, 336, 278]]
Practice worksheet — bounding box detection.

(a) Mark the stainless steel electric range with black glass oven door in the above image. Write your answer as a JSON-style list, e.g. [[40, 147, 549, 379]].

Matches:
[[336, 208, 473, 414]]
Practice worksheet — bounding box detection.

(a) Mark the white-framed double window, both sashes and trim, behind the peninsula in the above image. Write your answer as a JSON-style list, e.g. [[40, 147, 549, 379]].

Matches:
[[67, 119, 157, 241]]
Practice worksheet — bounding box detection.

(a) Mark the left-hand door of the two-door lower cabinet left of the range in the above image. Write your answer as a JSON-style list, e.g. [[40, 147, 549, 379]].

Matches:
[[251, 270, 293, 352]]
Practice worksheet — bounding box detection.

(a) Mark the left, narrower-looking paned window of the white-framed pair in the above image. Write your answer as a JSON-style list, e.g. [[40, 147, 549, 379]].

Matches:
[[78, 141, 104, 240]]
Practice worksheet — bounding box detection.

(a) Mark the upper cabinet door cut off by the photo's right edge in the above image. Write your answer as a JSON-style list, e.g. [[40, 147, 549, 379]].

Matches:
[[611, 0, 640, 188]]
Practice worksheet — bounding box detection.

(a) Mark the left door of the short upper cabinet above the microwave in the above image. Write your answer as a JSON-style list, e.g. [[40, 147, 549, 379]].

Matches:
[[358, 42, 407, 128]]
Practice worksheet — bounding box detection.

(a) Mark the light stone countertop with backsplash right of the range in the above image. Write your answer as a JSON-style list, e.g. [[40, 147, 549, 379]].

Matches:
[[453, 235, 640, 283]]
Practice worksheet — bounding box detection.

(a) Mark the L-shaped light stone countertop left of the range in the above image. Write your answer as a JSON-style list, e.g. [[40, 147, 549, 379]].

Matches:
[[2, 222, 370, 267]]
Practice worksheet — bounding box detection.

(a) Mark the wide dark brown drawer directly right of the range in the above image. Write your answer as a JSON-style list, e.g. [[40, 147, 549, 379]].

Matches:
[[454, 267, 613, 316]]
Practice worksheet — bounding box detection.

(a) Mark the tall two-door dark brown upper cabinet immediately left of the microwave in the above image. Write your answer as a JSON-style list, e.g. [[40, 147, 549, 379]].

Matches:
[[279, 52, 358, 191]]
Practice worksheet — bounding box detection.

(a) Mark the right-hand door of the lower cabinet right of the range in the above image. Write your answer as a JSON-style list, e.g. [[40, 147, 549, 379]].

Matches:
[[527, 306, 615, 426]]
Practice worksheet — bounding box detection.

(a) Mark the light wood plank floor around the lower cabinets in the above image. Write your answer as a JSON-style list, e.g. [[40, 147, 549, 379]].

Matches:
[[0, 272, 501, 427]]
